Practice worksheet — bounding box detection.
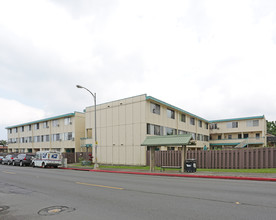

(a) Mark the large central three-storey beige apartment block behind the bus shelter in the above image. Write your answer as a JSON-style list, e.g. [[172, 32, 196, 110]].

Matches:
[[82, 95, 209, 165]]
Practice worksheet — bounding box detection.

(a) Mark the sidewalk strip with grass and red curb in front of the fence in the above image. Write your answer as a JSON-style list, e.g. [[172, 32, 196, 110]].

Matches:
[[62, 164, 276, 182]]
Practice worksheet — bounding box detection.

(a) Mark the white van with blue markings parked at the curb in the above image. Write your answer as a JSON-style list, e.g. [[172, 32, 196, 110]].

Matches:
[[32, 151, 62, 168]]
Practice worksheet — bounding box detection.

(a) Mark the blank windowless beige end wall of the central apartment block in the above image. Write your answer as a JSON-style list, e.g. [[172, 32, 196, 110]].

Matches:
[[86, 95, 146, 165]]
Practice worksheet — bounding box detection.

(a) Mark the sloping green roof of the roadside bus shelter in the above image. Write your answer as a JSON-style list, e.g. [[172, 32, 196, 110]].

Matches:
[[141, 134, 192, 147]]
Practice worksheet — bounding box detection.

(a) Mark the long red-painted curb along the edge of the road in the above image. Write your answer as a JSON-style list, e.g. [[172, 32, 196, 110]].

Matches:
[[59, 167, 276, 182]]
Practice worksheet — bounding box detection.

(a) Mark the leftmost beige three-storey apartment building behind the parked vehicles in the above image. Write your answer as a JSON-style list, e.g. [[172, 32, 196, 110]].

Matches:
[[6, 112, 85, 153]]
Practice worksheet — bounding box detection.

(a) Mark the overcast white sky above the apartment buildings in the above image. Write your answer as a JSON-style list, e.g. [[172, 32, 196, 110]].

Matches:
[[0, 0, 276, 139]]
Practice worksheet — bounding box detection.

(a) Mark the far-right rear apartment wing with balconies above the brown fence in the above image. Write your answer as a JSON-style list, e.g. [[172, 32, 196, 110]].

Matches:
[[209, 116, 267, 149]]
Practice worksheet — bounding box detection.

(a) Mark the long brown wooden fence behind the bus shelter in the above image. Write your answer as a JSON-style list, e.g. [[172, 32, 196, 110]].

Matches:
[[146, 148, 276, 169]]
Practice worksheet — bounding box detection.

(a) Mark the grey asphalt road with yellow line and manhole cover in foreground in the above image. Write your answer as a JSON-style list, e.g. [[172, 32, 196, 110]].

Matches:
[[0, 165, 276, 220]]
